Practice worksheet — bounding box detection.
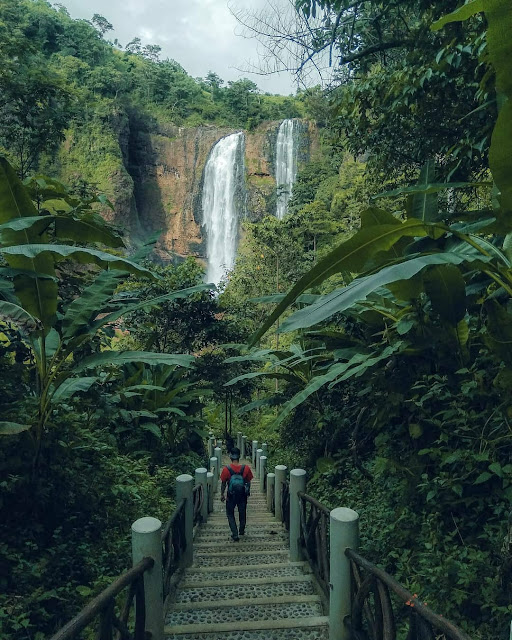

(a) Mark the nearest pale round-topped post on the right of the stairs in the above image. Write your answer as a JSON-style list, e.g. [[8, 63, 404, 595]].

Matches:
[[329, 507, 359, 640]]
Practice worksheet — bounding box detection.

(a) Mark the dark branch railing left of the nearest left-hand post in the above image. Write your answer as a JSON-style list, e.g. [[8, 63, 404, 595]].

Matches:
[[51, 558, 155, 640]]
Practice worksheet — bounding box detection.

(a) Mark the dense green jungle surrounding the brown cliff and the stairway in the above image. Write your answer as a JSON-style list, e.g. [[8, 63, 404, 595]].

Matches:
[[0, 0, 512, 640]]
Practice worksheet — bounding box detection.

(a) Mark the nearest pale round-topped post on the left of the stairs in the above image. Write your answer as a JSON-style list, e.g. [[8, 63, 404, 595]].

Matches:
[[132, 518, 164, 640]]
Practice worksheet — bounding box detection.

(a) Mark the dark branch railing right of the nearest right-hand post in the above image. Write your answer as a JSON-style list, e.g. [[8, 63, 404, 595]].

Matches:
[[345, 549, 470, 640]]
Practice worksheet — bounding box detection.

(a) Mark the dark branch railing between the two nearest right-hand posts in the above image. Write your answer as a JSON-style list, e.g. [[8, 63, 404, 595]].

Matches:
[[298, 491, 330, 596]]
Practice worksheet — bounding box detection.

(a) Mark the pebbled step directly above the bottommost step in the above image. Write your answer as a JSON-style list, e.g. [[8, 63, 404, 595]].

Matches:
[[165, 595, 323, 628]]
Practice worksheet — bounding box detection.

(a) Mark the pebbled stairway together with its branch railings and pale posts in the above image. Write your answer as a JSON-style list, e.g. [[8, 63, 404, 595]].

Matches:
[[47, 433, 471, 640]]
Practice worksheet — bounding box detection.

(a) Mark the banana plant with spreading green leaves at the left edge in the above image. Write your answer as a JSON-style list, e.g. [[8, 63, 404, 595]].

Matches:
[[0, 158, 212, 466]]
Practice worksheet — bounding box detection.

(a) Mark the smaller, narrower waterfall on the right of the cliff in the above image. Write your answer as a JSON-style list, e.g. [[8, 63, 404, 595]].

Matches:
[[276, 120, 298, 220]]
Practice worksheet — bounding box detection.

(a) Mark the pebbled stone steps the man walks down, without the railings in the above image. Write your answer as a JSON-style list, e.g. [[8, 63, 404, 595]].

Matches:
[[165, 462, 329, 640]]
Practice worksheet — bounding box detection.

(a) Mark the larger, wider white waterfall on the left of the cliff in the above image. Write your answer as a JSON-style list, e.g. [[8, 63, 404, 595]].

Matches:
[[202, 133, 245, 284]]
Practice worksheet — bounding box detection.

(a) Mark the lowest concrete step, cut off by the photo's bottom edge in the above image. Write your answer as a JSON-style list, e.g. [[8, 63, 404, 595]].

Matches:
[[165, 616, 329, 640]]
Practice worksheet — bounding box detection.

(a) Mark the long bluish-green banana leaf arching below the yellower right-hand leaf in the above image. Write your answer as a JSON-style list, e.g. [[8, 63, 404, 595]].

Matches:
[[279, 253, 480, 332]]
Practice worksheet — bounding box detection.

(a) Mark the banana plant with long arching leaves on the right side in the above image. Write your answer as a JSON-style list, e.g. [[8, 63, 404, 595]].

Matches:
[[244, 0, 512, 422]]
